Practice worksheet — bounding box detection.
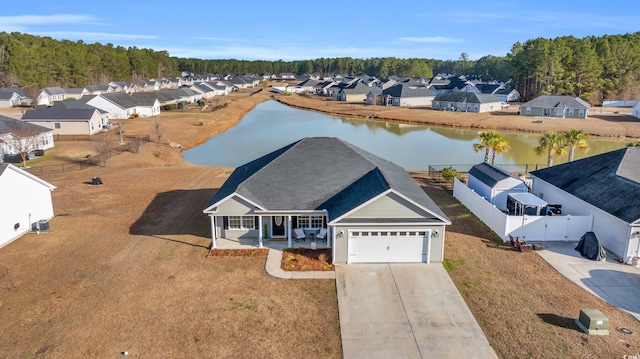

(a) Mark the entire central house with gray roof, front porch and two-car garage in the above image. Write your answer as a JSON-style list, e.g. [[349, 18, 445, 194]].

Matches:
[[204, 137, 451, 263]]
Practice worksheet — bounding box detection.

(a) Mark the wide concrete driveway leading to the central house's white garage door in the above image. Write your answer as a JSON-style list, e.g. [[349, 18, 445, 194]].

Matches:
[[336, 263, 497, 359]]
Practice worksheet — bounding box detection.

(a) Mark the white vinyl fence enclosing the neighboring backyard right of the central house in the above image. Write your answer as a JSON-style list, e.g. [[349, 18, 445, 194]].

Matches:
[[453, 179, 593, 242]]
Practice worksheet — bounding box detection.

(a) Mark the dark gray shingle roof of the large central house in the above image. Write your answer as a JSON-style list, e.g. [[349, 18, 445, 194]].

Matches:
[[207, 137, 448, 222]]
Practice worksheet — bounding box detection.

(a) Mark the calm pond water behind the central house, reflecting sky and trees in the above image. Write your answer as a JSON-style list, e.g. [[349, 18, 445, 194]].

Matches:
[[183, 101, 625, 171]]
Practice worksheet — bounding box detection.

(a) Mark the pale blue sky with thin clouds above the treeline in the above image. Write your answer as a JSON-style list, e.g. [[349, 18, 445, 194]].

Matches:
[[0, 0, 640, 61]]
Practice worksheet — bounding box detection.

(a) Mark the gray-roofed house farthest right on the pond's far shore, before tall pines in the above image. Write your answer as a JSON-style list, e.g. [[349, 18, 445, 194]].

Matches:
[[520, 95, 591, 118]]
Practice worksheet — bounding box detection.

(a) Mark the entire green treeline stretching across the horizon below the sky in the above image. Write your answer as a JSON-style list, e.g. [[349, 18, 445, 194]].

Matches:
[[0, 32, 640, 104]]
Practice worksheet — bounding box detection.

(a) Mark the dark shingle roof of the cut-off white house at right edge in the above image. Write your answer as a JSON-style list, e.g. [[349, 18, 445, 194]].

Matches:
[[531, 147, 640, 223]]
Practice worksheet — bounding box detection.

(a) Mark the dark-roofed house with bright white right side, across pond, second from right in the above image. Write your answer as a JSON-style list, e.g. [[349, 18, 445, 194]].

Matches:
[[431, 92, 502, 112]]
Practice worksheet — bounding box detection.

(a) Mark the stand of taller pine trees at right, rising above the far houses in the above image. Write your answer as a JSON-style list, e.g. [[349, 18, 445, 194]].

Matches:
[[506, 32, 640, 104]]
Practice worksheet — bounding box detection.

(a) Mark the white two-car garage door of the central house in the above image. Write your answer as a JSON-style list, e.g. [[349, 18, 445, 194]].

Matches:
[[348, 230, 431, 263]]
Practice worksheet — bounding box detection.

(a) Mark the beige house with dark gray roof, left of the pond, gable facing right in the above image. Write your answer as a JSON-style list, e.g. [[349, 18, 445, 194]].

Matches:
[[22, 100, 109, 135]]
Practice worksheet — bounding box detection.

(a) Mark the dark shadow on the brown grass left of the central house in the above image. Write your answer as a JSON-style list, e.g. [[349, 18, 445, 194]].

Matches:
[[129, 188, 218, 239]]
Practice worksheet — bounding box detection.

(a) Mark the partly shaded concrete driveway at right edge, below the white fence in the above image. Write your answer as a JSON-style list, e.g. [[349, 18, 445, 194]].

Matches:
[[536, 242, 640, 320]]
